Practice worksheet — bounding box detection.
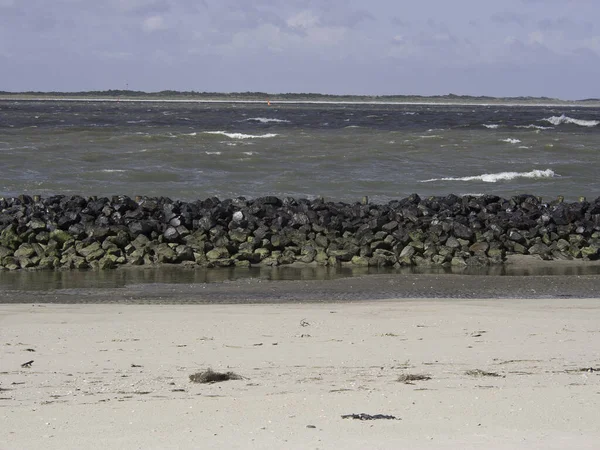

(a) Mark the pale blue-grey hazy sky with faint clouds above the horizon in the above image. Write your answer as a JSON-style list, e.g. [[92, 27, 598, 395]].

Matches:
[[0, 0, 600, 100]]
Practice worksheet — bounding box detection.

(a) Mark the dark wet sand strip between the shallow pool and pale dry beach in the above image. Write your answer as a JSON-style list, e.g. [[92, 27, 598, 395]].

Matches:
[[0, 274, 600, 304]]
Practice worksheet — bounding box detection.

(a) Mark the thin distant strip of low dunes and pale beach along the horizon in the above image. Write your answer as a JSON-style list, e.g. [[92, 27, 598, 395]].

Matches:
[[0, 94, 600, 108]]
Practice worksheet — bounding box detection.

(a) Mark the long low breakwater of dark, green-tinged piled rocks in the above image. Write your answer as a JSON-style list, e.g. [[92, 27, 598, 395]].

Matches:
[[0, 194, 600, 270]]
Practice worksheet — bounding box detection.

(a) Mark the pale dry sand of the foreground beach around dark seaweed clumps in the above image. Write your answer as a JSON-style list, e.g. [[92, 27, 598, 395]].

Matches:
[[0, 296, 600, 450]]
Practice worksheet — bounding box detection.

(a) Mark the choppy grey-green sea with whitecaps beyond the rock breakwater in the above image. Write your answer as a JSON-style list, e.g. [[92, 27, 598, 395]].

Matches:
[[0, 101, 600, 202]]
